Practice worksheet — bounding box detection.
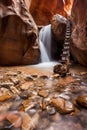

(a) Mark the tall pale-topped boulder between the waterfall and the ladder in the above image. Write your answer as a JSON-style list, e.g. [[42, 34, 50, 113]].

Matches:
[[51, 14, 67, 60]]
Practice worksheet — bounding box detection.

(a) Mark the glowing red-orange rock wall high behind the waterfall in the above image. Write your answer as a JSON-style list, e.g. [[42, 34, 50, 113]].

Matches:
[[30, 0, 70, 25]]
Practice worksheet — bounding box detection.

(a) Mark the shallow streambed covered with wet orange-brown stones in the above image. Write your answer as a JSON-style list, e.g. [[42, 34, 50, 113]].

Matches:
[[0, 63, 87, 130]]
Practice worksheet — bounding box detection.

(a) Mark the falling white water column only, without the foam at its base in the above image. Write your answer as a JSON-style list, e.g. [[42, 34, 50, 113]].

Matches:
[[39, 25, 51, 62]]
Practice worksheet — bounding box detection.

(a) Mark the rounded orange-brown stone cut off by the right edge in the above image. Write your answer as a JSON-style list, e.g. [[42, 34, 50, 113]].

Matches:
[[77, 95, 87, 108]]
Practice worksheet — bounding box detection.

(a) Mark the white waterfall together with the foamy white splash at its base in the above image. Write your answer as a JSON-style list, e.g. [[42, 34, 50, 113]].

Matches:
[[29, 25, 58, 70]]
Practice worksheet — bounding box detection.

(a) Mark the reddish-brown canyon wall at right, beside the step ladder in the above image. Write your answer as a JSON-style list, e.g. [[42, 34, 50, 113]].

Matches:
[[71, 0, 87, 66]]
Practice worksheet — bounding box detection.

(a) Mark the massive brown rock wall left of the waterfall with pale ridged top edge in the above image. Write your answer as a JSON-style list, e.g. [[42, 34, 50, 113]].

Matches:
[[0, 0, 40, 65]]
